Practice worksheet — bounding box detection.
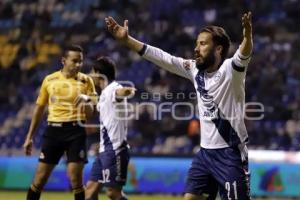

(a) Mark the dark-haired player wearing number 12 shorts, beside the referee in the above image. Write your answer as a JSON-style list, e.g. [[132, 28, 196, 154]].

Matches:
[[85, 57, 135, 200]]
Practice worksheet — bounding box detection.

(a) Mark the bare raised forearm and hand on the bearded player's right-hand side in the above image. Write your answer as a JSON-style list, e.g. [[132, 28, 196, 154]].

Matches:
[[240, 12, 253, 57]]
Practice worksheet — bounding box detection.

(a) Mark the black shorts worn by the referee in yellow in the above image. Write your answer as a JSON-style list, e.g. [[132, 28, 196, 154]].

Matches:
[[39, 122, 87, 164]]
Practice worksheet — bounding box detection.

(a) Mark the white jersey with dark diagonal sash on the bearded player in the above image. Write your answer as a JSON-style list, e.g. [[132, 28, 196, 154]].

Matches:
[[141, 45, 250, 149]]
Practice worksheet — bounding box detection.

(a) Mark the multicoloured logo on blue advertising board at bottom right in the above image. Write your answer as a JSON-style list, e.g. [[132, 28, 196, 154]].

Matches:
[[259, 167, 284, 192]]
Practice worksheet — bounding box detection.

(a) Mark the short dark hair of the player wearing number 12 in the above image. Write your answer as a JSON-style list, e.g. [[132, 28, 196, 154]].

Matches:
[[93, 56, 116, 81]]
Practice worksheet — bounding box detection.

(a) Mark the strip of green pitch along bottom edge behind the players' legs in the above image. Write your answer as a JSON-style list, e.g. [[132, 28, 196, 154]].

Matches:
[[0, 190, 182, 200]]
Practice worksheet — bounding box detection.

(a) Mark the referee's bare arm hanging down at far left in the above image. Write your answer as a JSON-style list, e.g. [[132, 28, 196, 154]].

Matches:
[[23, 104, 45, 156]]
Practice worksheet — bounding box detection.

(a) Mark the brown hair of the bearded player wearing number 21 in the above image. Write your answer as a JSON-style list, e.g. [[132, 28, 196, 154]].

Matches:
[[200, 26, 230, 60]]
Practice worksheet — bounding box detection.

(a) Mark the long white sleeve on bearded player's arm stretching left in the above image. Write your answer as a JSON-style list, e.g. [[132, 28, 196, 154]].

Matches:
[[139, 45, 195, 81]]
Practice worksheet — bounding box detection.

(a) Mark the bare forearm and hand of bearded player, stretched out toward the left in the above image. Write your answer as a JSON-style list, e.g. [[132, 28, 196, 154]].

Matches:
[[105, 16, 144, 52]]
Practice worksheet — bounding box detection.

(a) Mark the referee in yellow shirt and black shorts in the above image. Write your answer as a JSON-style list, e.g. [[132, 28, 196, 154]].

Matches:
[[23, 45, 96, 200]]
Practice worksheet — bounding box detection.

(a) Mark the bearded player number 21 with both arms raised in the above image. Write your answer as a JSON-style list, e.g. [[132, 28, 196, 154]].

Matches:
[[105, 12, 253, 200]]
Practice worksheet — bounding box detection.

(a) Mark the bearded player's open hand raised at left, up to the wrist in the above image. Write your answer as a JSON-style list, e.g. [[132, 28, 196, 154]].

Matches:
[[105, 16, 128, 41]]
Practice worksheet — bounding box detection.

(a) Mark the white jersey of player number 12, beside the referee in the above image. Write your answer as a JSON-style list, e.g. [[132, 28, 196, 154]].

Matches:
[[97, 81, 127, 153]]
